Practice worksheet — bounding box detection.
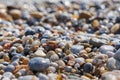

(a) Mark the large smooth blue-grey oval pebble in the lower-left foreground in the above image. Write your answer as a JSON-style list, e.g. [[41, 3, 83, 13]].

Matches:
[[29, 57, 50, 71]]
